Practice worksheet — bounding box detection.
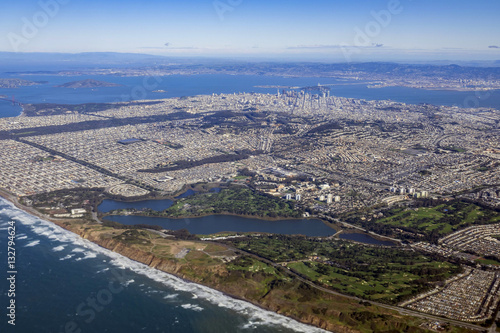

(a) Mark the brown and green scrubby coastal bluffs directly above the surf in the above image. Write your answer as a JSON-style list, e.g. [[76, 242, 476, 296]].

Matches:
[[56, 218, 425, 333]]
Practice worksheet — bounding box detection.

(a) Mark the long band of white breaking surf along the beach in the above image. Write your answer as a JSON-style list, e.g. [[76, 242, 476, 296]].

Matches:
[[0, 198, 326, 333]]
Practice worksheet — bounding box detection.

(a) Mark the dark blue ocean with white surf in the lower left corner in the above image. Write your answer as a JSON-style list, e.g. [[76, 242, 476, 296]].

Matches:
[[0, 199, 325, 333]]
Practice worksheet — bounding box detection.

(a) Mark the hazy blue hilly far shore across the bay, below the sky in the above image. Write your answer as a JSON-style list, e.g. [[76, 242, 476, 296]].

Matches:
[[9, 59, 500, 92]]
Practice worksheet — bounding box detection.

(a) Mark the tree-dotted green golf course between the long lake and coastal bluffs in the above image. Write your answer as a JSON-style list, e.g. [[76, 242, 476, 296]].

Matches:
[[224, 236, 460, 303]]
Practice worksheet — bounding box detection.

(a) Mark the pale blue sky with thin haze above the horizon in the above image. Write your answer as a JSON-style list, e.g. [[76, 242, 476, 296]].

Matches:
[[0, 0, 500, 61]]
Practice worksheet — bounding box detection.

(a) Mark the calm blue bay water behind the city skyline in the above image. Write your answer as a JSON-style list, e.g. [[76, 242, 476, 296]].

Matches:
[[0, 73, 500, 117]]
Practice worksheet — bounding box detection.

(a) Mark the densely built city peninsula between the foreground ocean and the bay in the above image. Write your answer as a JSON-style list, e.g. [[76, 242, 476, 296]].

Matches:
[[0, 82, 500, 332]]
